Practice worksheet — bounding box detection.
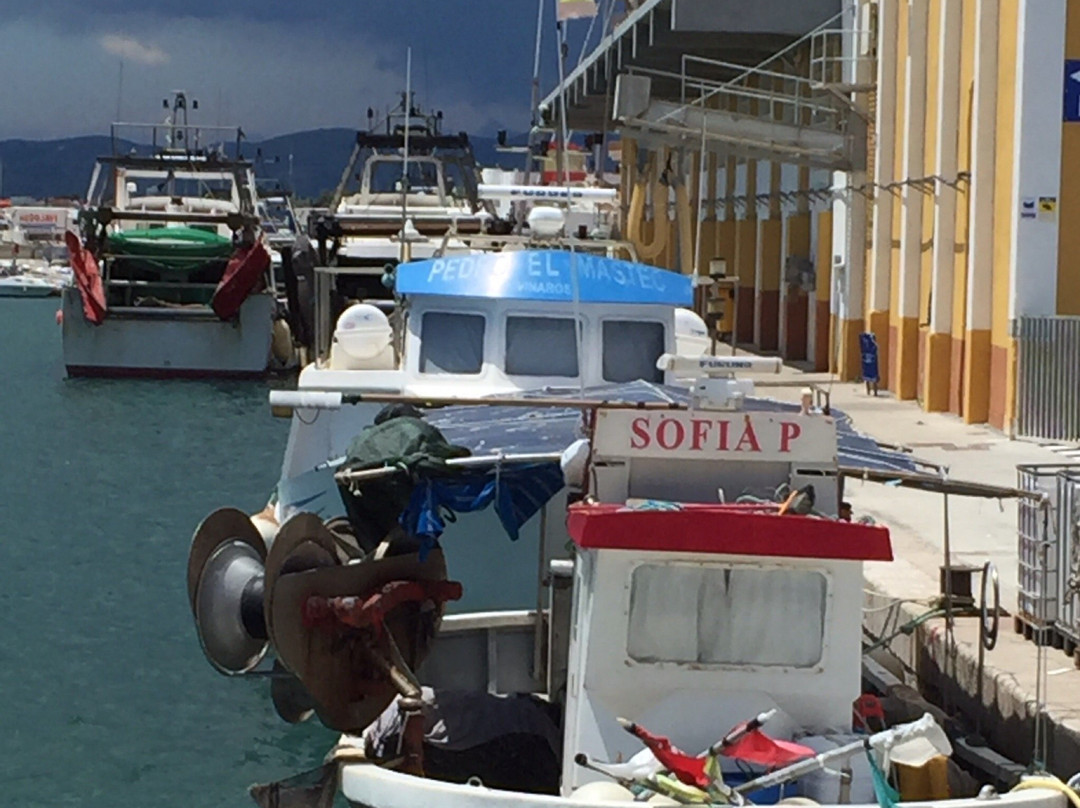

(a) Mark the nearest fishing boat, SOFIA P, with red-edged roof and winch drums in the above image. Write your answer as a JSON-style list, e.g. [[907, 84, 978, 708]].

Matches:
[[188, 354, 1080, 808]]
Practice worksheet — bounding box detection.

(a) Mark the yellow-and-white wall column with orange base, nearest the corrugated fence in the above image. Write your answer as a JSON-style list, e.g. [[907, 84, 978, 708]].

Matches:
[[963, 0, 999, 423]]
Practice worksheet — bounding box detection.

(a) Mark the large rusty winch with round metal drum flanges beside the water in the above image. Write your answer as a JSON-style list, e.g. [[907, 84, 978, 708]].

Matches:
[[188, 508, 460, 732]]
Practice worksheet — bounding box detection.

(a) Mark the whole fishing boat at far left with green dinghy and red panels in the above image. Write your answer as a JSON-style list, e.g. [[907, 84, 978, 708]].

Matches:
[[63, 93, 291, 378]]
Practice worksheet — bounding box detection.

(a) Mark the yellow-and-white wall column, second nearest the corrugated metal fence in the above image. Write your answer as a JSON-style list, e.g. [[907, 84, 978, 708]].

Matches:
[[922, 2, 967, 412]]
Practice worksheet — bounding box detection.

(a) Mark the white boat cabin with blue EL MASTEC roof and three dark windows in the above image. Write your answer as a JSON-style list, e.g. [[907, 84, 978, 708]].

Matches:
[[279, 250, 707, 488]]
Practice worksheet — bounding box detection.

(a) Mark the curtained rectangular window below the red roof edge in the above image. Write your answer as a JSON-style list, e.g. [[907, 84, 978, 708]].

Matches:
[[626, 564, 828, 668]]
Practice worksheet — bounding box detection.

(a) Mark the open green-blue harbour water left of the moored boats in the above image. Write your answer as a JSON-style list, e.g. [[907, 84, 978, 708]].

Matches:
[[0, 299, 335, 808]]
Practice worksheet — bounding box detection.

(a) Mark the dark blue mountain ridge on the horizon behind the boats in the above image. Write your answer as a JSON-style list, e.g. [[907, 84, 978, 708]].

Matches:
[[0, 127, 524, 199]]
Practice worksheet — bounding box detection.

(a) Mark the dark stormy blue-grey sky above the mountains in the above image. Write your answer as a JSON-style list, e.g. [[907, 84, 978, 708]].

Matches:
[[0, 0, 599, 139]]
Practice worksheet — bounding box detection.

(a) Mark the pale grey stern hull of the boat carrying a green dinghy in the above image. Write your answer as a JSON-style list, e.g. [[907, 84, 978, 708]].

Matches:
[[62, 289, 275, 378]]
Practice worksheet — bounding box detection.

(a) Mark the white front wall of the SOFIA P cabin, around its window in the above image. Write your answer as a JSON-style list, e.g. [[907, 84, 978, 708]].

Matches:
[[564, 550, 862, 793]]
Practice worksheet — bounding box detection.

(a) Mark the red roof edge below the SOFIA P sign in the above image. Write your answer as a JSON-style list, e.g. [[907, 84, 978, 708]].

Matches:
[[567, 502, 892, 561]]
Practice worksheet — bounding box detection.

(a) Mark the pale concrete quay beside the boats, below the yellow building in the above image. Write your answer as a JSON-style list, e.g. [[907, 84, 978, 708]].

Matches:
[[747, 354, 1080, 778]]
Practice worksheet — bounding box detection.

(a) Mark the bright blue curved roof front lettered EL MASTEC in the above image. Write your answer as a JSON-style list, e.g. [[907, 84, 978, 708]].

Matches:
[[394, 250, 693, 307]]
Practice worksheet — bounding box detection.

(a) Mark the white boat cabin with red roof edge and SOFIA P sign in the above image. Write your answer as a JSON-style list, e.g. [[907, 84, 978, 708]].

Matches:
[[562, 395, 891, 794]]
